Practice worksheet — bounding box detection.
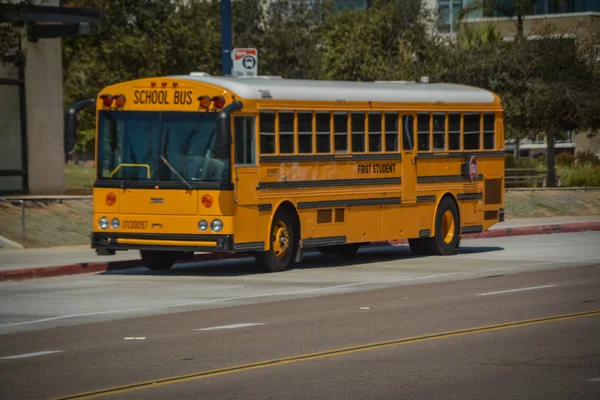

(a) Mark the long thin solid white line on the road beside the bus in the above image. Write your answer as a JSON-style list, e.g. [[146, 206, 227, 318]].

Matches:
[[0, 272, 454, 328]]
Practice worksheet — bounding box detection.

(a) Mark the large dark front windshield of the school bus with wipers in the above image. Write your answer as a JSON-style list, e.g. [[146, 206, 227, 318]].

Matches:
[[98, 111, 229, 188]]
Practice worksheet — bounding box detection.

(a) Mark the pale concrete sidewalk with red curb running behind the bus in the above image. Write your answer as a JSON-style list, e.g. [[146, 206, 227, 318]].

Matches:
[[0, 215, 600, 281]]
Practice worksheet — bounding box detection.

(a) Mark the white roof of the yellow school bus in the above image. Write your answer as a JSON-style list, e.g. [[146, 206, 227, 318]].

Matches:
[[170, 74, 494, 104]]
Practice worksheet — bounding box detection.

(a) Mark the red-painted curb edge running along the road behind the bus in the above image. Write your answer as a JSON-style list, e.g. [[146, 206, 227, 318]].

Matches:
[[0, 222, 600, 282]]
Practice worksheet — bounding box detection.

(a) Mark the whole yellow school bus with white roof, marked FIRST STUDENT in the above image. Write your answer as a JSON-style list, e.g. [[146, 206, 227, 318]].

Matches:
[[66, 73, 504, 272]]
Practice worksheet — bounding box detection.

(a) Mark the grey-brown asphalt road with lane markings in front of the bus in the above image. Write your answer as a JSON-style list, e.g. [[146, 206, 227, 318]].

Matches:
[[0, 232, 600, 400]]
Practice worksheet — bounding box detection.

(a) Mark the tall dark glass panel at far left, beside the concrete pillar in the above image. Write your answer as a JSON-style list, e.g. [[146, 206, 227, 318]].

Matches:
[[0, 85, 23, 170]]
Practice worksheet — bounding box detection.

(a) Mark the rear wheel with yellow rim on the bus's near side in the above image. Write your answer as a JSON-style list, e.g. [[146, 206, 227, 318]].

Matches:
[[428, 197, 460, 256]]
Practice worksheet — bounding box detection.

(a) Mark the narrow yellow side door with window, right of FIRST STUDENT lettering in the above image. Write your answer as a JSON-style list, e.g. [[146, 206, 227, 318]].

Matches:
[[401, 114, 417, 205]]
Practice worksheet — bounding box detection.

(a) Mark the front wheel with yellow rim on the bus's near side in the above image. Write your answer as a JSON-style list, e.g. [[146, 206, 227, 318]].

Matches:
[[255, 209, 299, 272]]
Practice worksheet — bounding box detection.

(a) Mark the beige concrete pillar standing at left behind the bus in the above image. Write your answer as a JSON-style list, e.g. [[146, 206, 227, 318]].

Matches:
[[22, 0, 65, 194]]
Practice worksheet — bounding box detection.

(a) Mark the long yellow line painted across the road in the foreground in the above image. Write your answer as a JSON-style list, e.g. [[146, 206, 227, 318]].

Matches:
[[54, 310, 600, 400]]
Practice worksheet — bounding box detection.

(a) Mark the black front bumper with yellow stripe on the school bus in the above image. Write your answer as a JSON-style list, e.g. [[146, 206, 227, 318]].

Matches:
[[92, 232, 236, 254]]
